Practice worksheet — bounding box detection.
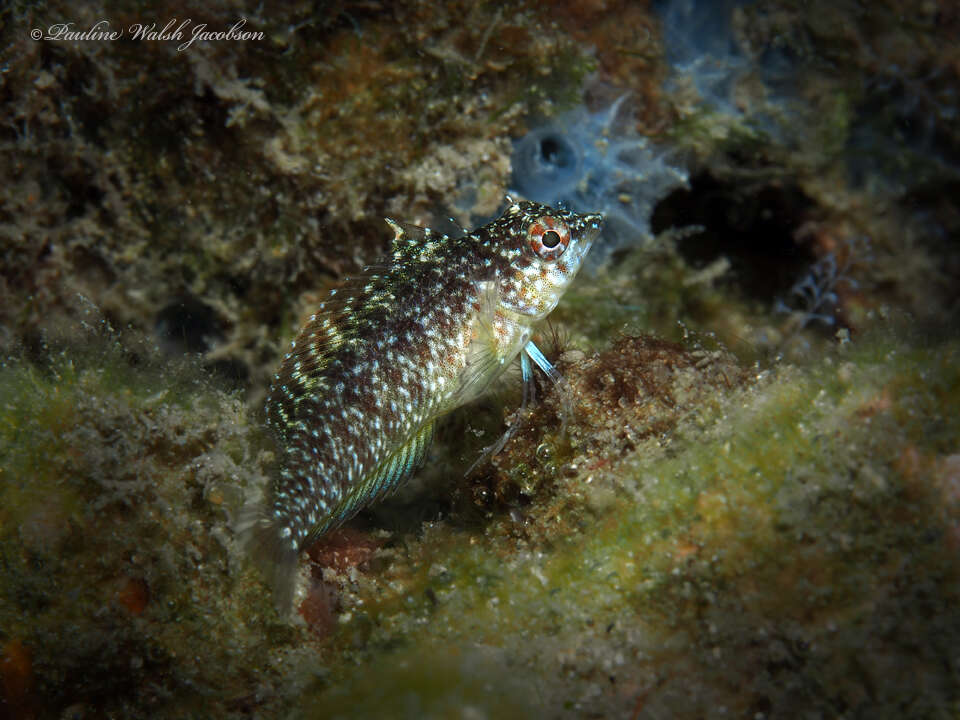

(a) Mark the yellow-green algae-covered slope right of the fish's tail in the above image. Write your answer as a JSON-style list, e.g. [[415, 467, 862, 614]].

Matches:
[[306, 324, 960, 717]]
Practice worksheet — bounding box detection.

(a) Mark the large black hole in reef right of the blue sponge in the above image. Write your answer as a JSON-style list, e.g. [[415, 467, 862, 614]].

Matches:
[[650, 173, 816, 305]]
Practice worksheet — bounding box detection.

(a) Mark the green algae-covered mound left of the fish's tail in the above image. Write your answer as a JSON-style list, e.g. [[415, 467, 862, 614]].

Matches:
[[0, 320, 316, 717]]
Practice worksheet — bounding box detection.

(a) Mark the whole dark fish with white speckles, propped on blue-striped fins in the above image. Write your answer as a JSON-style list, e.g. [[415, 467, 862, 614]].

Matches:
[[241, 202, 603, 612]]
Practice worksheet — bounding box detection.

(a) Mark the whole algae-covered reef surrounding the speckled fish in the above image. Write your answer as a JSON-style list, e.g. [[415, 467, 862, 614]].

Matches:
[[0, 0, 960, 720]]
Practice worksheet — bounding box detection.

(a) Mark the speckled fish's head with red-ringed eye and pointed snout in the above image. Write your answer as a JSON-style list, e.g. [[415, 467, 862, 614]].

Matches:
[[497, 202, 603, 320]]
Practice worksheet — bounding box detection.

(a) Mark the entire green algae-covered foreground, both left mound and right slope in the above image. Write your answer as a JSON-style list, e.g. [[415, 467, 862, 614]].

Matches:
[[0, 304, 960, 718]]
